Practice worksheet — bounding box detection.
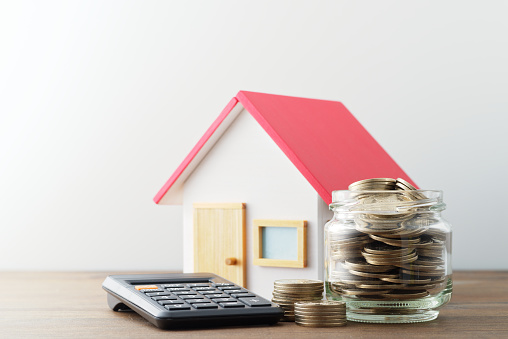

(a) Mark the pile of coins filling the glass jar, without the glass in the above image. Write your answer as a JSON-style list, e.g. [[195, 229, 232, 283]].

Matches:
[[327, 178, 447, 301]]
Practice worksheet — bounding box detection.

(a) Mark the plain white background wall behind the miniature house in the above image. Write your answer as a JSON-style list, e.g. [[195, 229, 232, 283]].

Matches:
[[0, 0, 508, 270]]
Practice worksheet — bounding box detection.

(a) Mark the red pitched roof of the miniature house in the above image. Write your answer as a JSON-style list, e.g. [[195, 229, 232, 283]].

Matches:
[[154, 91, 414, 204]]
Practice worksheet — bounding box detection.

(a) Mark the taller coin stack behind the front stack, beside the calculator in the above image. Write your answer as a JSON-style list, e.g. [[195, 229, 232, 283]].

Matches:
[[272, 279, 323, 321]]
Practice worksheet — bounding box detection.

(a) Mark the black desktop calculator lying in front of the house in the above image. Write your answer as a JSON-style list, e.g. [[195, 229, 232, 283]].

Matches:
[[102, 273, 284, 329]]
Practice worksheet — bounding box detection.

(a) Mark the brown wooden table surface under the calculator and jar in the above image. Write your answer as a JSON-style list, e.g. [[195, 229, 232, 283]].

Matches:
[[0, 271, 508, 339]]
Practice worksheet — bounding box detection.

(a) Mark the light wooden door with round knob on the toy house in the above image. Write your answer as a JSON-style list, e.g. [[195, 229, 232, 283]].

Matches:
[[193, 203, 246, 287]]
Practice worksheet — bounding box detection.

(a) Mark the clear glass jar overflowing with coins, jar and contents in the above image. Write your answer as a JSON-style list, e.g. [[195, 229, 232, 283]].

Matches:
[[325, 178, 452, 323]]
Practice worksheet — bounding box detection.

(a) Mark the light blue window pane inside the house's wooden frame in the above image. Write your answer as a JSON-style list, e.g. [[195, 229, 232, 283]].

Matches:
[[261, 227, 298, 260]]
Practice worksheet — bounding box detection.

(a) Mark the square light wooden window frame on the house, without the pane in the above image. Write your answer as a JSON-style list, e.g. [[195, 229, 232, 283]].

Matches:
[[252, 219, 307, 268]]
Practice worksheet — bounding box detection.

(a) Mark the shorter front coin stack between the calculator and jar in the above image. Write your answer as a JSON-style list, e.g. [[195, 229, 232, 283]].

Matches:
[[295, 300, 346, 327]]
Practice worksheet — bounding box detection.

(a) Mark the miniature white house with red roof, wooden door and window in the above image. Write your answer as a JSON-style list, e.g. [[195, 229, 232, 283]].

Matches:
[[154, 91, 412, 298]]
